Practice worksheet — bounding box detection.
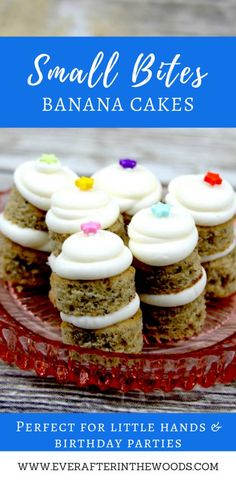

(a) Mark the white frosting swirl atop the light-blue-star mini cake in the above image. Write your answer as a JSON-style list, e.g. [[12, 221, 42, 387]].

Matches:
[[128, 207, 198, 266]]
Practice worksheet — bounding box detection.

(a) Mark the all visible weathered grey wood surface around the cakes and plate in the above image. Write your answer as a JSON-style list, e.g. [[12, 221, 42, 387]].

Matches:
[[0, 0, 236, 412]]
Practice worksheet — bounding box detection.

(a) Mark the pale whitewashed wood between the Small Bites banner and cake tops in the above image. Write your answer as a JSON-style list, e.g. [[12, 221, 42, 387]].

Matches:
[[0, 129, 236, 186]]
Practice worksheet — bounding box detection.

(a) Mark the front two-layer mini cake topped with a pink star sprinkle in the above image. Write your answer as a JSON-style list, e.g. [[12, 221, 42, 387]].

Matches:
[[49, 222, 143, 353]]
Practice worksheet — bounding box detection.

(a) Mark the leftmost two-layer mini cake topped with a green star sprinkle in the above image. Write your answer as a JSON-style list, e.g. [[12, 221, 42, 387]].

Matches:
[[0, 155, 76, 287]]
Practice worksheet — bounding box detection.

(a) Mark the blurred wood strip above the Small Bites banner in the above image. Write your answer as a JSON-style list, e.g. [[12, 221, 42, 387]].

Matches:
[[0, 0, 236, 36]]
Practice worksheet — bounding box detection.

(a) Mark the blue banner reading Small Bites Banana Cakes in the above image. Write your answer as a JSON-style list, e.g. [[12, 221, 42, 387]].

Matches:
[[0, 37, 236, 127]]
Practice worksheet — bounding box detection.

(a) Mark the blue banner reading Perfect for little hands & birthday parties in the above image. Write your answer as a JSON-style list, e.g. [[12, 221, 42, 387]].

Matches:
[[0, 413, 236, 451]]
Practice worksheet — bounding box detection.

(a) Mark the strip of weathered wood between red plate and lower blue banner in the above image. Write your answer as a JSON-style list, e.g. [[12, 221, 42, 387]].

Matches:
[[0, 362, 236, 413]]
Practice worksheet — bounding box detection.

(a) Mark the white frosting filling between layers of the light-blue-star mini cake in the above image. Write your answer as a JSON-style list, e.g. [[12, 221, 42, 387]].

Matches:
[[140, 268, 207, 307]]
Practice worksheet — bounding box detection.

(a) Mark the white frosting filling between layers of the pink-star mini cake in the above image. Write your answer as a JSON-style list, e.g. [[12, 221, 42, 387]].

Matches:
[[60, 294, 140, 329]]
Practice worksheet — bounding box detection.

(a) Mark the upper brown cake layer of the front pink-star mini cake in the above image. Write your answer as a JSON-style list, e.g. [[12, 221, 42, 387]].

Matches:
[[50, 267, 135, 316]]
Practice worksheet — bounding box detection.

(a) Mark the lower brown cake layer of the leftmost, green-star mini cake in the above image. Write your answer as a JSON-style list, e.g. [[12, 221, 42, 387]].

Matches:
[[0, 234, 50, 288]]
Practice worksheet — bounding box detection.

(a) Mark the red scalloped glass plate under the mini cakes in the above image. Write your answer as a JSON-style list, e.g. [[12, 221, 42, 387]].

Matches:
[[0, 188, 236, 392]]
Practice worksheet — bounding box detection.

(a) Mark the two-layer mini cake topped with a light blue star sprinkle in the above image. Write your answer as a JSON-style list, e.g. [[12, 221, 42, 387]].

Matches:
[[128, 202, 206, 341]]
